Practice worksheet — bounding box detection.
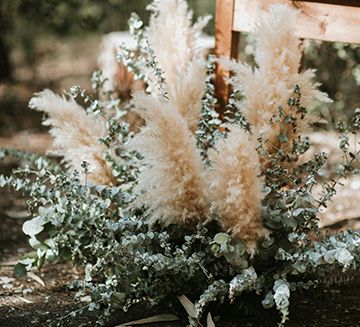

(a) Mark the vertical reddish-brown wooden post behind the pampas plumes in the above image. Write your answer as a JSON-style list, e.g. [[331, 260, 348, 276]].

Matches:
[[215, 0, 239, 113]]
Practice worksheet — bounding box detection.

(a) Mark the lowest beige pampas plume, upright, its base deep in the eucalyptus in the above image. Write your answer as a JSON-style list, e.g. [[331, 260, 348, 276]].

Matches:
[[209, 126, 268, 254]]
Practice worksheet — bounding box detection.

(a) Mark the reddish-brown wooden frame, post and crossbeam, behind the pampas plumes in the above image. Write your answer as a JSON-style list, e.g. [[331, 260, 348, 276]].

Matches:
[[215, 0, 360, 111]]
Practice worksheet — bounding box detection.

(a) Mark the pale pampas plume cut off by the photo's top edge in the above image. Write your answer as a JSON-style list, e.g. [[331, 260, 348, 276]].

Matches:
[[147, 0, 210, 133]]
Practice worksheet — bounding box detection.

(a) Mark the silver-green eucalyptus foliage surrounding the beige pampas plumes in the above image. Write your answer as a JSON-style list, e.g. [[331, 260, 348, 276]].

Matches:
[[0, 12, 360, 325]]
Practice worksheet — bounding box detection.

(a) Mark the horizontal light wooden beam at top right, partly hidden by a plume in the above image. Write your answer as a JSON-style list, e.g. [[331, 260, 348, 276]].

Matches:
[[233, 0, 360, 44]]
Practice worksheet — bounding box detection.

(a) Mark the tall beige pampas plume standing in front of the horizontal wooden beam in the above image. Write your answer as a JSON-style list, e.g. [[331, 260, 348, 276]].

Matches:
[[224, 5, 331, 158]]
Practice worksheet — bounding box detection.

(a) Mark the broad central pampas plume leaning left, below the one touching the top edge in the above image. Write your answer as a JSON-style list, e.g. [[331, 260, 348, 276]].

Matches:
[[129, 92, 208, 225]]
